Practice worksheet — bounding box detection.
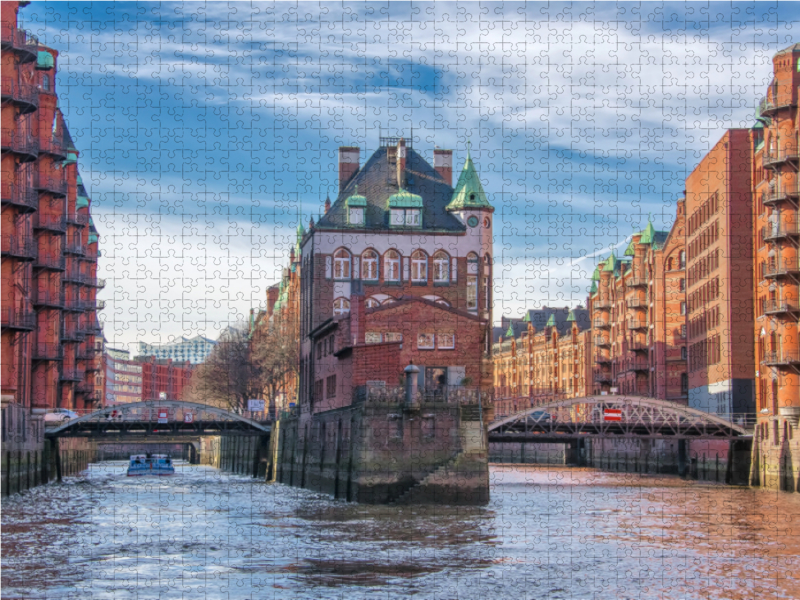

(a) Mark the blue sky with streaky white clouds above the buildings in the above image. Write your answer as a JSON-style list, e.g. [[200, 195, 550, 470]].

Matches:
[[20, 2, 800, 351]]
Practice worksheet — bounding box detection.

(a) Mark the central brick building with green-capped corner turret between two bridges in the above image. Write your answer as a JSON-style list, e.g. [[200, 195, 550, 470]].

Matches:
[[300, 138, 494, 412]]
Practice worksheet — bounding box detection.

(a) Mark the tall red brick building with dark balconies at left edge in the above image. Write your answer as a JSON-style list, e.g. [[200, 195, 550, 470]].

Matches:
[[0, 1, 103, 450]]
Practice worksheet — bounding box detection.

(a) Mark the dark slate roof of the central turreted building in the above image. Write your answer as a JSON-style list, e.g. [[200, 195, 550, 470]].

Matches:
[[315, 146, 466, 233]]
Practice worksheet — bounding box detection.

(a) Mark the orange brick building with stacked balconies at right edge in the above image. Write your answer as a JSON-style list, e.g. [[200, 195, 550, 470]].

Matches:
[[751, 44, 800, 490]]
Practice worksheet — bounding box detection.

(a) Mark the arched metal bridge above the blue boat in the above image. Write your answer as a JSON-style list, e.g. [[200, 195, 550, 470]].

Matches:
[[45, 400, 272, 442]]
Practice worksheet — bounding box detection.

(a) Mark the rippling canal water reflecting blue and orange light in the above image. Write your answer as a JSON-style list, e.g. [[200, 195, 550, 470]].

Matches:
[[2, 462, 800, 600]]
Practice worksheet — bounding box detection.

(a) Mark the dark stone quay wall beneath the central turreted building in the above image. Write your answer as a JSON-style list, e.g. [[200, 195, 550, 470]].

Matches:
[[272, 397, 489, 505]]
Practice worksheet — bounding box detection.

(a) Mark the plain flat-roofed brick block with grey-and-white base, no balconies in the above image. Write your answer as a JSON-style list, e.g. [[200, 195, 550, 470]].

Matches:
[[686, 129, 755, 416]]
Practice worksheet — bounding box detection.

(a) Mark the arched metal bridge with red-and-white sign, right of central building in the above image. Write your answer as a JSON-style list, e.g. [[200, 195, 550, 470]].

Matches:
[[488, 396, 756, 443]]
